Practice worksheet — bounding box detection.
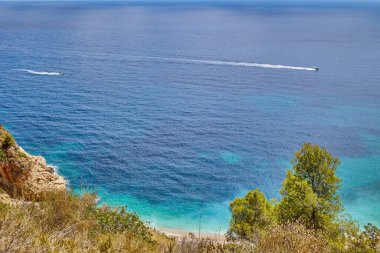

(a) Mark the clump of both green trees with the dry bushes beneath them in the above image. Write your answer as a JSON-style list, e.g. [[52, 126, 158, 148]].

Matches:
[[227, 143, 380, 253]]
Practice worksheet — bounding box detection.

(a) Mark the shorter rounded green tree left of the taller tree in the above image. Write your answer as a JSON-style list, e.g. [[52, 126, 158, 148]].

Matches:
[[227, 189, 275, 240]]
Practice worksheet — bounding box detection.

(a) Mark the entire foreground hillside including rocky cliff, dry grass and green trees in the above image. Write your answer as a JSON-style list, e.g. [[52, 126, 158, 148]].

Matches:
[[0, 126, 380, 253]]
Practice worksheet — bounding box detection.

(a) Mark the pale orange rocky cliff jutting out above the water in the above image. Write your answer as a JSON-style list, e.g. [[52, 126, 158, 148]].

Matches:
[[0, 125, 66, 201]]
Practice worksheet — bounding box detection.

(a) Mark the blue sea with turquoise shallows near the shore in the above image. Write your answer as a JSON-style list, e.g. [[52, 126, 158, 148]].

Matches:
[[0, 3, 380, 231]]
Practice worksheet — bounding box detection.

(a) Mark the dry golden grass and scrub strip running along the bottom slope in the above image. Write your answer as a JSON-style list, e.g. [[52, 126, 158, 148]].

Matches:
[[0, 195, 328, 253]]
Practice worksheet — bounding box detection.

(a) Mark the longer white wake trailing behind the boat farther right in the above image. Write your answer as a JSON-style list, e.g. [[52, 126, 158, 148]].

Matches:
[[130, 56, 318, 71]]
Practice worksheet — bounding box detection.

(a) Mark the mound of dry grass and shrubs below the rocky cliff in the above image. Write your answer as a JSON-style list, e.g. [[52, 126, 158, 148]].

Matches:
[[0, 193, 158, 253]]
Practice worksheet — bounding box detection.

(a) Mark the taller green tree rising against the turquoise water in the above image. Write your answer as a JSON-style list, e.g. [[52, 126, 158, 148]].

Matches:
[[278, 143, 342, 229]]
